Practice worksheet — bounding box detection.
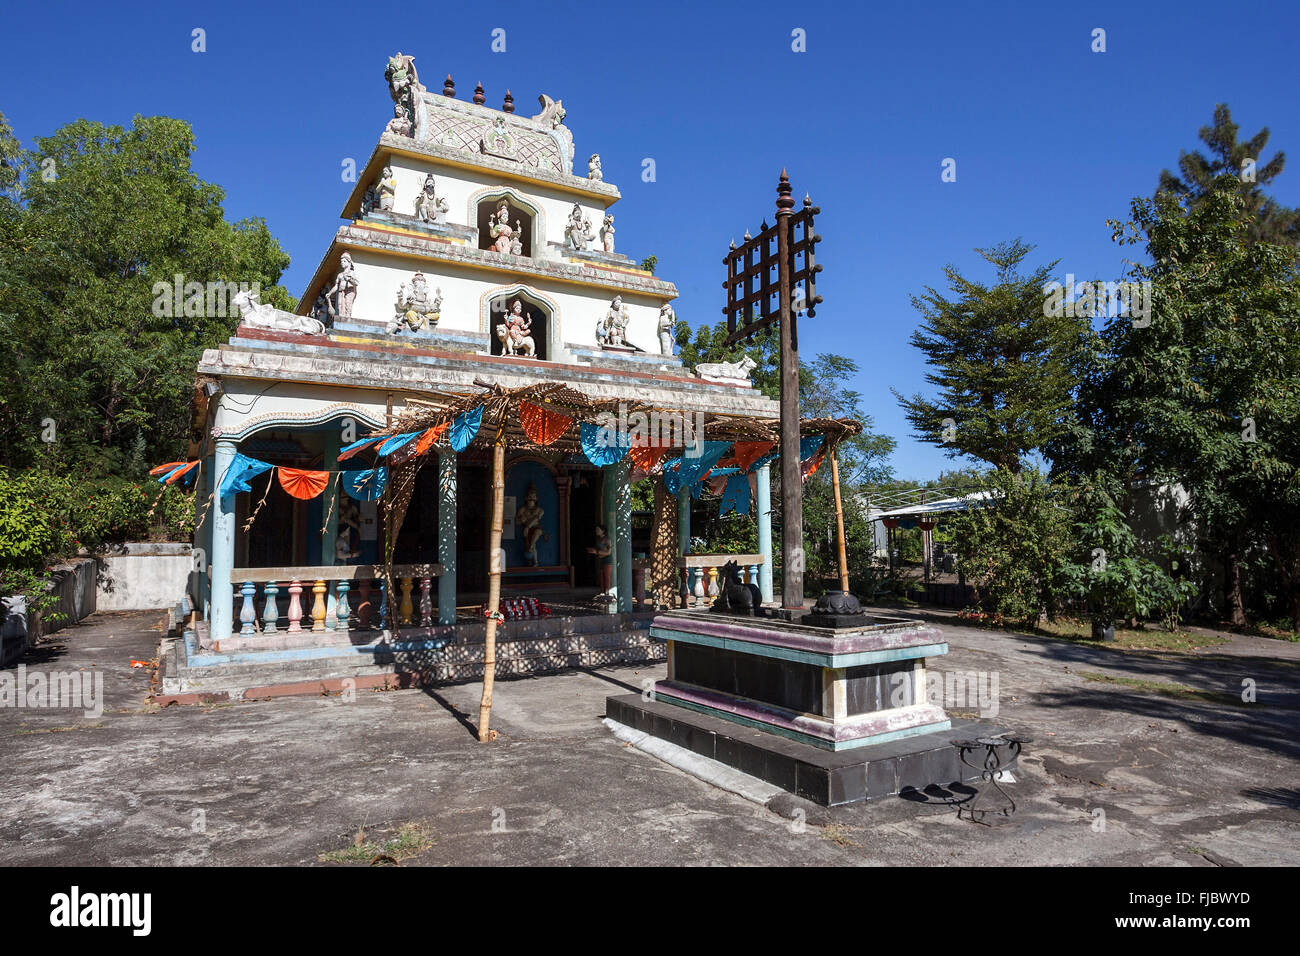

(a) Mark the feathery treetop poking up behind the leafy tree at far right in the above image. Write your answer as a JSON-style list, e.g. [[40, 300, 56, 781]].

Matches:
[[1158, 103, 1300, 246]]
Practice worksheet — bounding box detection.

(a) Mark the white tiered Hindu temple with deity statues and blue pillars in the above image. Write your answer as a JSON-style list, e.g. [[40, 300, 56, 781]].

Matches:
[[160, 53, 835, 693]]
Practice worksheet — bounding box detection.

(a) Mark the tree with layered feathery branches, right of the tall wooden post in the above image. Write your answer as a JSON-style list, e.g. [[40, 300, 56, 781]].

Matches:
[[894, 239, 1088, 473]]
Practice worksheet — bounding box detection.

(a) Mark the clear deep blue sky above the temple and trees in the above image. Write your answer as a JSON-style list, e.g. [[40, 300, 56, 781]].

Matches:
[[0, 0, 1300, 477]]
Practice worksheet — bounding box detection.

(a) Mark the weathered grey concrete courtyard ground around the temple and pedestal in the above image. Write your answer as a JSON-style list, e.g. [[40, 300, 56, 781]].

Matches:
[[0, 611, 1300, 866]]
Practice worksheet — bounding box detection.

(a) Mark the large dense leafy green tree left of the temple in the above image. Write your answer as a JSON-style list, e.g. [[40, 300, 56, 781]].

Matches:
[[0, 116, 294, 472]]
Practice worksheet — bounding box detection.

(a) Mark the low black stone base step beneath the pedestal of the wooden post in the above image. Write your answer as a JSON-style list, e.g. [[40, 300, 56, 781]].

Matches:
[[605, 693, 1015, 806]]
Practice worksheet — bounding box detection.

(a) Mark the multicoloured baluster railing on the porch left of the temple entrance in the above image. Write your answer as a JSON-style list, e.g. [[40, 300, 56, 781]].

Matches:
[[230, 564, 442, 637]]
